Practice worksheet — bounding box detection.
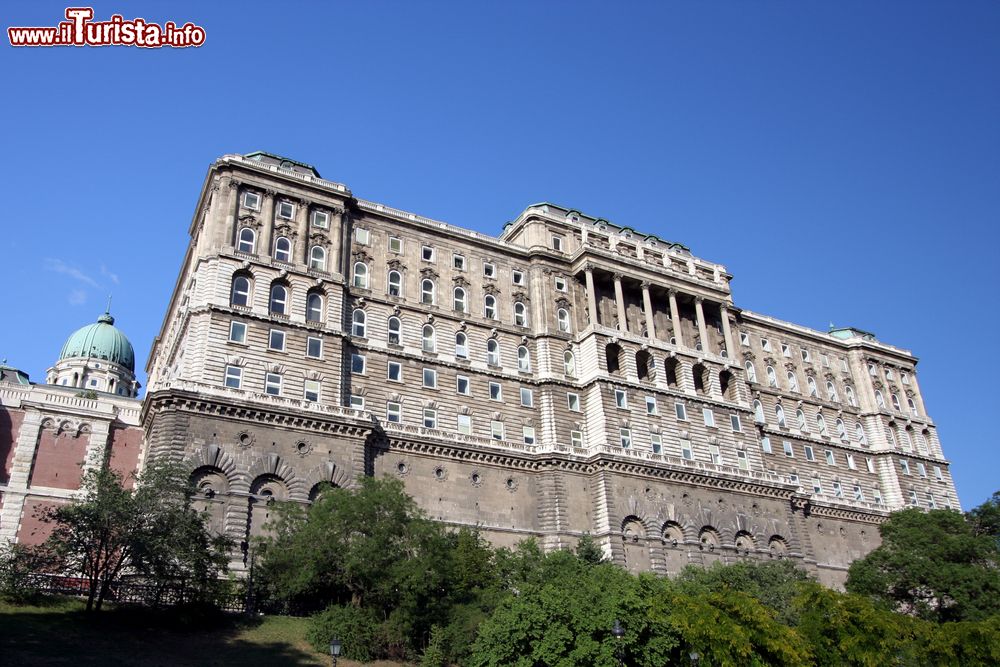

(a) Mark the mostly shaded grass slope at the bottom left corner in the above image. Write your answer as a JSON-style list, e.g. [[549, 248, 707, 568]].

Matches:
[[0, 598, 406, 667]]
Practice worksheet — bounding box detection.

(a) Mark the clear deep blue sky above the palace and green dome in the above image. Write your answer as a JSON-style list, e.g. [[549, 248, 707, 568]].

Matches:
[[0, 1, 1000, 507]]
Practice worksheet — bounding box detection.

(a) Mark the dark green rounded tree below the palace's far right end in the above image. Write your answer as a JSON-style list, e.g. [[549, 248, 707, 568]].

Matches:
[[847, 508, 1000, 622]]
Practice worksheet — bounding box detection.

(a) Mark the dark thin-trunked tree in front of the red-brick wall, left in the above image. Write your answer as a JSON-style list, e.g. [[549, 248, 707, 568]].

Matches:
[[40, 464, 231, 611]]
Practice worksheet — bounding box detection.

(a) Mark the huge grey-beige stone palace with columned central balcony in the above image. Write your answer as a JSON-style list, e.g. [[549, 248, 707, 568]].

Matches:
[[0, 153, 958, 585]]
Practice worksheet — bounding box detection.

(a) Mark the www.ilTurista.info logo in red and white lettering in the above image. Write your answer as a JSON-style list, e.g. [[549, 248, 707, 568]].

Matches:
[[7, 7, 205, 49]]
